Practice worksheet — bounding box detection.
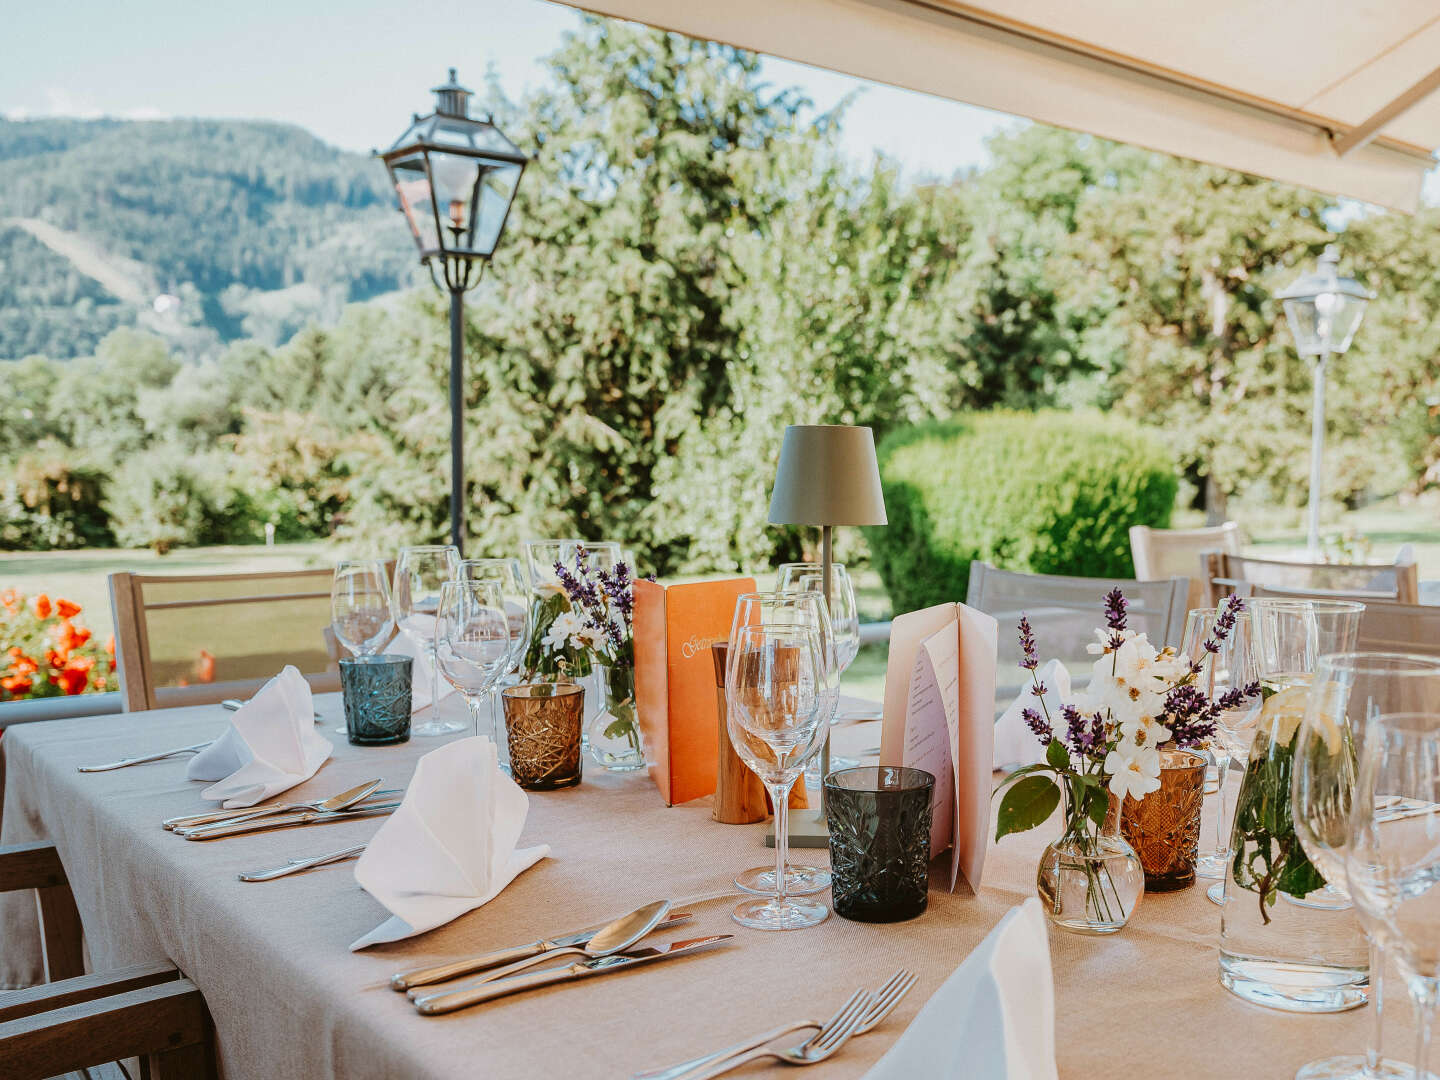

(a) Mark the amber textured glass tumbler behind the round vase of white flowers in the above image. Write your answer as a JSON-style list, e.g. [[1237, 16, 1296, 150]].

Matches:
[[1120, 750, 1205, 893]]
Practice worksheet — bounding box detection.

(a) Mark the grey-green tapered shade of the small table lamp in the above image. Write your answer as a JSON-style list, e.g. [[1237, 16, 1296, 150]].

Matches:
[[770, 423, 888, 526]]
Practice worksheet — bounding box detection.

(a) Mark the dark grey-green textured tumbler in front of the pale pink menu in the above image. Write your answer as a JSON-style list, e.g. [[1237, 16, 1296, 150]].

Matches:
[[825, 766, 935, 923]]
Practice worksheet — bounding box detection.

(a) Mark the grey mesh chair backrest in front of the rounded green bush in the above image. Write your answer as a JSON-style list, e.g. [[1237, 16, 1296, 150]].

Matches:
[[965, 562, 1189, 708]]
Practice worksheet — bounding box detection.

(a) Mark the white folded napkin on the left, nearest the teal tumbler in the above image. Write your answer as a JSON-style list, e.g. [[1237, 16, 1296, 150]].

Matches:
[[186, 664, 336, 809]]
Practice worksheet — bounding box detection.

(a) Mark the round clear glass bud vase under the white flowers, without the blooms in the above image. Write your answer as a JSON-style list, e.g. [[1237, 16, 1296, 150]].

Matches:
[[1035, 796, 1145, 935]]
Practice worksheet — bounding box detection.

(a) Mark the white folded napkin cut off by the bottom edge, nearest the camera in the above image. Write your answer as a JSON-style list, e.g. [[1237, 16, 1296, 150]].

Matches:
[[865, 897, 1057, 1080]]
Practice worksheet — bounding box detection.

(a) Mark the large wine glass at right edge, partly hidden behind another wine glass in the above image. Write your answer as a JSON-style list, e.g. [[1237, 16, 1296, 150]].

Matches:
[[1290, 652, 1440, 1080]]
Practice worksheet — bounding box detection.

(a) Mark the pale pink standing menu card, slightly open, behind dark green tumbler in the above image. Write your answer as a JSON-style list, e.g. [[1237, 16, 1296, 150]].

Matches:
[[880, 603, 998, 891]]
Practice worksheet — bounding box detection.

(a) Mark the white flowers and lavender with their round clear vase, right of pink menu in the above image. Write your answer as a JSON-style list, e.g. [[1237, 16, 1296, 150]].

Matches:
[[995, 589, 1259, 933]]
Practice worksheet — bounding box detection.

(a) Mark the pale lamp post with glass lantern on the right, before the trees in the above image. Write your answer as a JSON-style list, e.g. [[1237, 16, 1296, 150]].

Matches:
[[1280, 243, 1375, 562]]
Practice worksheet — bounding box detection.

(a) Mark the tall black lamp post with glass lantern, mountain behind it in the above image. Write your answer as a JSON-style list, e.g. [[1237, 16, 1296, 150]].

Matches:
[[377, 68, 530, 553]]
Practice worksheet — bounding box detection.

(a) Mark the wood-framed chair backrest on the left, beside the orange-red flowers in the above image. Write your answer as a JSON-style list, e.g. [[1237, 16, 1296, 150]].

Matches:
[[109, 567, 340, 711]]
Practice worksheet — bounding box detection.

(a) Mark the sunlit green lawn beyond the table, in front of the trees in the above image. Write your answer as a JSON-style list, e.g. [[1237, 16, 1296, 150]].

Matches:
[[0, 500, 1440, 698]]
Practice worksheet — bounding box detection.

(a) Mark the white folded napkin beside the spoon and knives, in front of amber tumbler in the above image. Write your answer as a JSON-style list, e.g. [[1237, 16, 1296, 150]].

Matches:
[[350, 736, 550, 949]]
